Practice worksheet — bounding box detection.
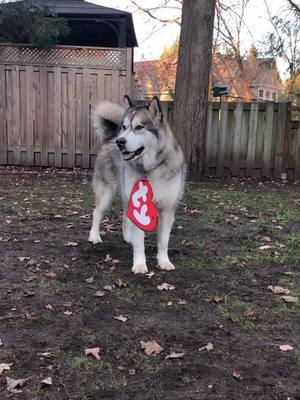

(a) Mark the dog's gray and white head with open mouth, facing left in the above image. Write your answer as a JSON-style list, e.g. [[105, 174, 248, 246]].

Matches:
[[116, 96, 163, 164]]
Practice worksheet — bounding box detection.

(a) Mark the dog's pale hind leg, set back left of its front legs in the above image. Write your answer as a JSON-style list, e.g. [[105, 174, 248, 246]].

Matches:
[[88, 186, 115, 244]]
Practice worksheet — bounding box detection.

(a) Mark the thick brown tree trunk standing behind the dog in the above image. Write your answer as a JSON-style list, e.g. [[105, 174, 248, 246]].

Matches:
[[174, 0, 216, 180]]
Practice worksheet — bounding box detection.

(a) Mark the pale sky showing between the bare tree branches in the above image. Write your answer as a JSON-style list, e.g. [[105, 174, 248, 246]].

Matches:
[[88, 0, 300, 77]]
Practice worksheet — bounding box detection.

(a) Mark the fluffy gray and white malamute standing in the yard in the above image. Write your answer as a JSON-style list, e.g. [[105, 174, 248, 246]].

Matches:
[[89, 96, 185, 274]]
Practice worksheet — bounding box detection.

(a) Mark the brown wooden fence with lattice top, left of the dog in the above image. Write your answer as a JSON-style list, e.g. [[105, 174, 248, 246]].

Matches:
[[0, 44, 132, 168]]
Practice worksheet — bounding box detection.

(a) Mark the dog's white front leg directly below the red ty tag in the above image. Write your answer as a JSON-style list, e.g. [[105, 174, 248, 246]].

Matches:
[[128, 221, 148, 274]]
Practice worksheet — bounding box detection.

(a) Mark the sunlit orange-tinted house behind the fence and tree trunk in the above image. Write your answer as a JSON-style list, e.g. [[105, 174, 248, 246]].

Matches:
[[134, 53, 283, 102]]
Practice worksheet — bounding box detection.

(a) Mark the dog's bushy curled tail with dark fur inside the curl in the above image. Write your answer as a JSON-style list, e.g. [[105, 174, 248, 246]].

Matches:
[[92, 100, 124, 143]]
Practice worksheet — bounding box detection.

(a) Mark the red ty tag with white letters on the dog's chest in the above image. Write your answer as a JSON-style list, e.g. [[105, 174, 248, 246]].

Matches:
[[127, 178, 158, 232]]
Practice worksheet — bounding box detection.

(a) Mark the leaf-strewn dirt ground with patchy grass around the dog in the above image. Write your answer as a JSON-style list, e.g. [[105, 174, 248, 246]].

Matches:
[[0, 168, 300, 400]]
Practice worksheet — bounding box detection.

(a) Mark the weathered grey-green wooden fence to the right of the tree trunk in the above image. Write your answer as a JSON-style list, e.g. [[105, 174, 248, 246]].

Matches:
[[164, 102, 300, 180]]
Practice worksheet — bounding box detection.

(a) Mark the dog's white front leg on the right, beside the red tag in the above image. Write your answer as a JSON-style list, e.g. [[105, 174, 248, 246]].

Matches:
[[157, 210, 175, 271]]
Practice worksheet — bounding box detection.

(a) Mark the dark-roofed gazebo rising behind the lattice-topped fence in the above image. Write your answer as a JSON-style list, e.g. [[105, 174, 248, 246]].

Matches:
[[36, 0, 138, 47]]
